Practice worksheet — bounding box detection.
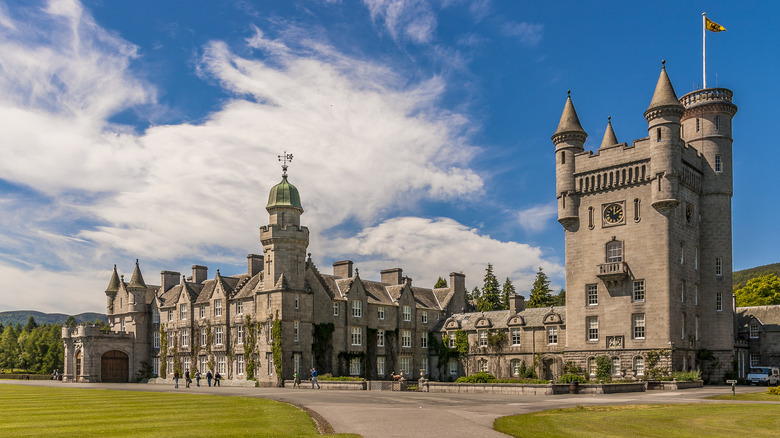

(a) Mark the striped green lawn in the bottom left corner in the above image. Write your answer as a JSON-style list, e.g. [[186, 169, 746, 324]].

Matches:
[[0, 385, 354, 437]]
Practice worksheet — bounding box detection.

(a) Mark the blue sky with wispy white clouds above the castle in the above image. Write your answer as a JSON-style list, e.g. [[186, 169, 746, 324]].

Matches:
[[0, 0, 780, 314]]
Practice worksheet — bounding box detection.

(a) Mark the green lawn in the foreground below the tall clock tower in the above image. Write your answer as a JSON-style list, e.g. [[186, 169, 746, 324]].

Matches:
[[494, 403, 780, 438]]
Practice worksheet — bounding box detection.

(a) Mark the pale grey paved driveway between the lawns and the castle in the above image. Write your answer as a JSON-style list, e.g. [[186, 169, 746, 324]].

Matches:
[[0, 380, 762, 438]]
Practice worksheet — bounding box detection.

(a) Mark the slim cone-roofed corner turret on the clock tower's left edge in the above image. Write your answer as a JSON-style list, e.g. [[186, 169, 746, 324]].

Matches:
[[552, 91, 588, 228]]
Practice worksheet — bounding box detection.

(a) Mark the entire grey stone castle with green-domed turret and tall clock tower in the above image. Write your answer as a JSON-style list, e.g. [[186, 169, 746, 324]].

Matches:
[[63, 66, 762, 385]]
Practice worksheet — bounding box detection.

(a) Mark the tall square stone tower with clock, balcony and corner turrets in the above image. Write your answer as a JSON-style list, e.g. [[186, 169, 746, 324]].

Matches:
[[552, 66, 737, 377]]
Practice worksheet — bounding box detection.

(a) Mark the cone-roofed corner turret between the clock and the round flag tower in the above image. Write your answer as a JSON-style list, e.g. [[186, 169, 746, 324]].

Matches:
[[645, 61, 685, 212]]
